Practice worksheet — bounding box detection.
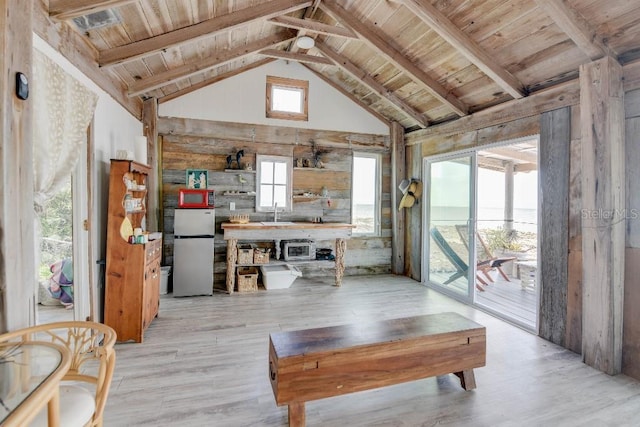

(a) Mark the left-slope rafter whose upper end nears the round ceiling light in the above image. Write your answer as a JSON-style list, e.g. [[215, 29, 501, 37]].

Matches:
[[128, 31, 295, 96]]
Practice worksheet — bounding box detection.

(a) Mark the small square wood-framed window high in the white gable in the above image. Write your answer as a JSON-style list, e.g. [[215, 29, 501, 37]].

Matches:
[[267, 76, 309, 121]]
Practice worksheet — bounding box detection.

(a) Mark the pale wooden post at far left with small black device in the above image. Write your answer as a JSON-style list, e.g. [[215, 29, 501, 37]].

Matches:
[[0, 0, 37, 333]]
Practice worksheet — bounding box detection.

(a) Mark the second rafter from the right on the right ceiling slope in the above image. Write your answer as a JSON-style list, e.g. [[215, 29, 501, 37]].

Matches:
[[401, 0, 526, 98]]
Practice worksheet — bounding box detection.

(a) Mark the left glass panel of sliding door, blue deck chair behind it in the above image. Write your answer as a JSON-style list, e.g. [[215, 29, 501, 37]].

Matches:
[[425, 155, 475, 301]]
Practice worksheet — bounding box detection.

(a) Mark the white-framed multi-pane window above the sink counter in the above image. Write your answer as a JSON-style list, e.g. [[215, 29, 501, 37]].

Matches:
[[256, 154, 293, 212]]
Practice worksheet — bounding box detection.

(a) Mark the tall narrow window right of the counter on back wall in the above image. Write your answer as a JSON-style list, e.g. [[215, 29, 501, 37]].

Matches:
[[351, 153, 381, 236]]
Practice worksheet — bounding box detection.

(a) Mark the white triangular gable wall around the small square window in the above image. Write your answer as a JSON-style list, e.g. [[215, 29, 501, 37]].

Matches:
[[158, 60, 389, 135]]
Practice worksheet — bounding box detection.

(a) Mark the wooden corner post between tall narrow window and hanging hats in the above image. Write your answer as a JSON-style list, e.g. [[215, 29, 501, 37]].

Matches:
[[391, 122, 406, 274]]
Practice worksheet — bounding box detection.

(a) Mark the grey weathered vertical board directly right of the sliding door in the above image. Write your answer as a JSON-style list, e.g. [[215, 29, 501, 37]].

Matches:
[[538, 107, 571, 345]]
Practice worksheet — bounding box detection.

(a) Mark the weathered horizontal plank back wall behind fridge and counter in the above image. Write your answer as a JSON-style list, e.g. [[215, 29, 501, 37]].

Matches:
[[158, 118, 392, 289]]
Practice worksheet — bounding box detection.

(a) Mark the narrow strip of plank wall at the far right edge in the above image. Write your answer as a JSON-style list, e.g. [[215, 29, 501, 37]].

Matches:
[[622, 90, 640, 380]]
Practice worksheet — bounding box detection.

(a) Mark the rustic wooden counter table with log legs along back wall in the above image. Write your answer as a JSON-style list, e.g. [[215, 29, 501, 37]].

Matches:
[[222, 221, 355, 294]]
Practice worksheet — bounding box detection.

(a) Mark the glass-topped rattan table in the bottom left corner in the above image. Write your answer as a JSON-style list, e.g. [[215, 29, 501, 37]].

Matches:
[[0, 341, 71, 427]]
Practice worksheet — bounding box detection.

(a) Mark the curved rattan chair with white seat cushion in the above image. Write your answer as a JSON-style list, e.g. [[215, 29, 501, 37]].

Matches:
[[0, 321, 116, 427]]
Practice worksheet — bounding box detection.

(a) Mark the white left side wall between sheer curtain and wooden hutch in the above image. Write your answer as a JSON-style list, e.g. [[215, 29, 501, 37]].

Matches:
[[33, 34, 142, 320]]
